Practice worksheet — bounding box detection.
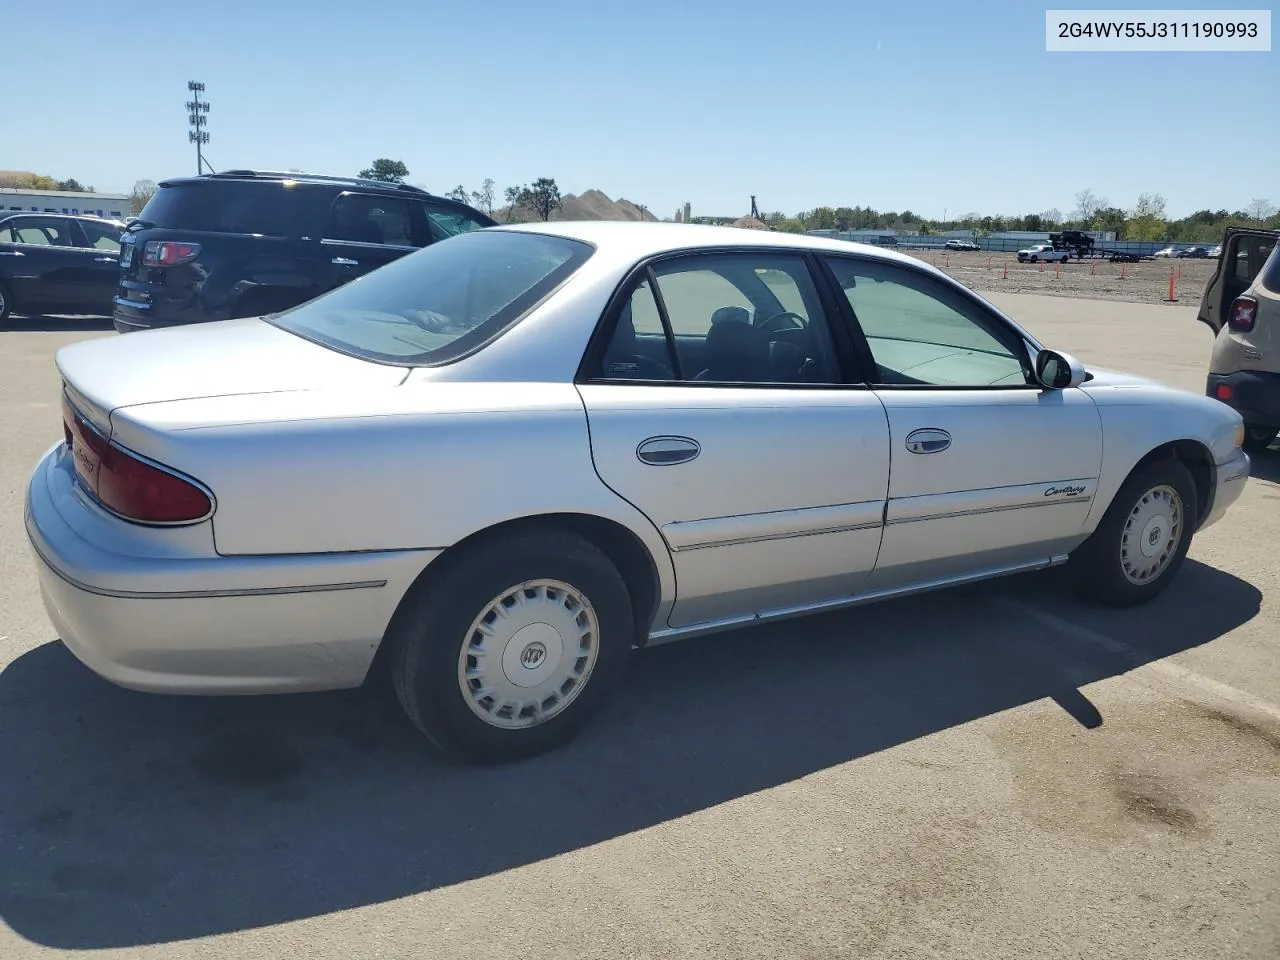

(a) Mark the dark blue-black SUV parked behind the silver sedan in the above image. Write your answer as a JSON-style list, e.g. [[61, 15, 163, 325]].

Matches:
[[114, 170, 497, 333]]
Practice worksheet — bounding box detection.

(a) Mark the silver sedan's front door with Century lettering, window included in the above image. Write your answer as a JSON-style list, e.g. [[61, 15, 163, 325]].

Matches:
[[827, 257, 1102, 588]]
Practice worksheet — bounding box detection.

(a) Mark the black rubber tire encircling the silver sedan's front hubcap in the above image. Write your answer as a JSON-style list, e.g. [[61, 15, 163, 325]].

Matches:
[[1069, 458, 1199, 607]]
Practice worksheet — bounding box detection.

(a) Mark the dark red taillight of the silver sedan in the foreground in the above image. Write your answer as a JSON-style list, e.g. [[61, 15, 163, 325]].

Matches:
[[63, 397, 214, 524]]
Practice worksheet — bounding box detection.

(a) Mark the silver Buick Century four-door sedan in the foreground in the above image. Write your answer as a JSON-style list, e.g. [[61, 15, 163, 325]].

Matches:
[[27, 223, 1249, 760]]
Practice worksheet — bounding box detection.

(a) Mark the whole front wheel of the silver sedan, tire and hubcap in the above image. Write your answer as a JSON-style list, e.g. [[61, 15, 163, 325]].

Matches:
[[1070, 460, 1199, 607]]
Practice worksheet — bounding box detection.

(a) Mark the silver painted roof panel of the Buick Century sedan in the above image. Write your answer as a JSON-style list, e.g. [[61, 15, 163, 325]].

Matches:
[[489, 220, 928, 266]]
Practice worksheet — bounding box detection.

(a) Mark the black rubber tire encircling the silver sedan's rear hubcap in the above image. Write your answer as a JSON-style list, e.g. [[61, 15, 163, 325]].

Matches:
[[385, 527, 635, 763]]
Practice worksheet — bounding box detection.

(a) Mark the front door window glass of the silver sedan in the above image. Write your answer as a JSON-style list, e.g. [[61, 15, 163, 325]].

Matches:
[[828, 257, 1032, 387]]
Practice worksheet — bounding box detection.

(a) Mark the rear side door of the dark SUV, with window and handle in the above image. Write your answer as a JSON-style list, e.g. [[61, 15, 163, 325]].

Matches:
[[320, 191, 426, 288]]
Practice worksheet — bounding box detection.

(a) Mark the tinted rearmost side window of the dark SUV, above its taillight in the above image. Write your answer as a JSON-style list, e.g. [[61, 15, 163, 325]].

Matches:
[[138, 180, 300, 237]]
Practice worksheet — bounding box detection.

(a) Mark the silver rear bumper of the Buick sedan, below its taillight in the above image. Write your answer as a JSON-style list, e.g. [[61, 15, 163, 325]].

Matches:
[[26, 444, 438, 694]]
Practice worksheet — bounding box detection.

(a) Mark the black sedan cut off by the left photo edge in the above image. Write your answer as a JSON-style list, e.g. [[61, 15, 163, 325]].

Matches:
[[0, 214, 124, 323]]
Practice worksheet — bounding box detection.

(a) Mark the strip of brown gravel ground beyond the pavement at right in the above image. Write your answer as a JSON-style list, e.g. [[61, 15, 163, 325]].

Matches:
[[901, 251, 1217, 308]]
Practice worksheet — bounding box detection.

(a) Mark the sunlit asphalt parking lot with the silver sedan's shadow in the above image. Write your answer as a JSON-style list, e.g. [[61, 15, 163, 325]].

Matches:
[[0, 302, 1280, 960]]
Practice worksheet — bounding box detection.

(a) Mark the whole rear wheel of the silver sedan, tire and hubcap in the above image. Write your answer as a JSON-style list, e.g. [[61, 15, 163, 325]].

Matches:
[[387, 529, 635, 763]]
